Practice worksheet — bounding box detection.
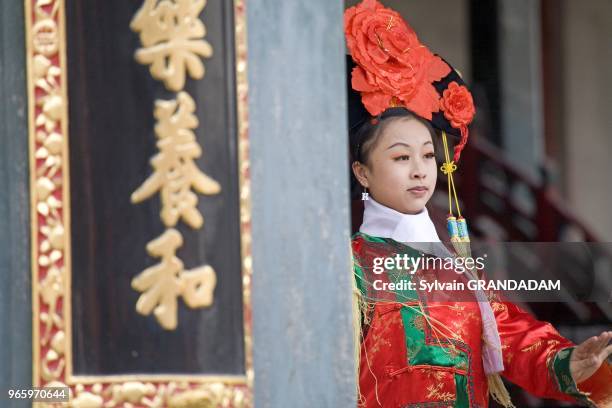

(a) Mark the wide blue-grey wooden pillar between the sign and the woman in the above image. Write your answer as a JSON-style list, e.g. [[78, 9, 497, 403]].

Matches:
[[247, 0, 356, 408]]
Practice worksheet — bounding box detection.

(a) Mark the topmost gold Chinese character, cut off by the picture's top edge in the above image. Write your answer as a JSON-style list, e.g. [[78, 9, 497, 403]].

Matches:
[[130, 0, 213, 91]]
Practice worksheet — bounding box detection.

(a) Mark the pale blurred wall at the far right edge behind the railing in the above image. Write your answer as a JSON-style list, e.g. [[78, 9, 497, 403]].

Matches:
[[561, 0, 612, 241]]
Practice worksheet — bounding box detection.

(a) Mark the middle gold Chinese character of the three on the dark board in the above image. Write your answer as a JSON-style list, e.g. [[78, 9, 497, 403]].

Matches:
[[131, 92, 221, 228]]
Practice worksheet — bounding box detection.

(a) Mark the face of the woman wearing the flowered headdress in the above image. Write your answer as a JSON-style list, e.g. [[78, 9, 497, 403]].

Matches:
[[353, 118, 437, 214]]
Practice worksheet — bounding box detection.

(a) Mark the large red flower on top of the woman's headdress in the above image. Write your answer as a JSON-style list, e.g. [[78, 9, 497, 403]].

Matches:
[[344, 0, 450, 120]]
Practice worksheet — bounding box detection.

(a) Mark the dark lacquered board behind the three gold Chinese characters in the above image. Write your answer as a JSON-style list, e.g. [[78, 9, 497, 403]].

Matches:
[[66, 0, 244, 375]]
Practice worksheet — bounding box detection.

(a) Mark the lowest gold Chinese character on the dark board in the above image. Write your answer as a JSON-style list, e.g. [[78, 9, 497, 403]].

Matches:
[[132, 228, 217, 330]]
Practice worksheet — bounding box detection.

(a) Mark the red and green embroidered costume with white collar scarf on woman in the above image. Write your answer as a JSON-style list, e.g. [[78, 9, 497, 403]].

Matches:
[[352, 199, 612, 408]]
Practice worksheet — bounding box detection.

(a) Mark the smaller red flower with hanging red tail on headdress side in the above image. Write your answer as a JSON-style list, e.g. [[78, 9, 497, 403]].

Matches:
[[440, 81, 476, 162]]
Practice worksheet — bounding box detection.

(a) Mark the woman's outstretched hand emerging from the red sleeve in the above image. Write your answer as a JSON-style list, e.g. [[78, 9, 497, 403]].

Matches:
[[570, 332, 612, 384]]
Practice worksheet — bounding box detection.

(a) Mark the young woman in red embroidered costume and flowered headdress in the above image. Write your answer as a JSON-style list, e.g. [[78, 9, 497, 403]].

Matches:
[[345, 0, 612, 408]]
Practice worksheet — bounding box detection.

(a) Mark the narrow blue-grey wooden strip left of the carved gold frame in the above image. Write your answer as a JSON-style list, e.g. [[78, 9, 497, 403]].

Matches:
[[0, 1, 32, 407]]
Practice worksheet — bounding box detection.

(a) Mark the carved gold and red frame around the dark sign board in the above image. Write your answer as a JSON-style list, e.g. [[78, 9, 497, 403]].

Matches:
[[24, 0, 253, 407]]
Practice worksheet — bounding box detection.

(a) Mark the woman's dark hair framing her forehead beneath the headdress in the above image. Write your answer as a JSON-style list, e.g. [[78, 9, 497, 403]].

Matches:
[[349, 107, 444, 199]]
